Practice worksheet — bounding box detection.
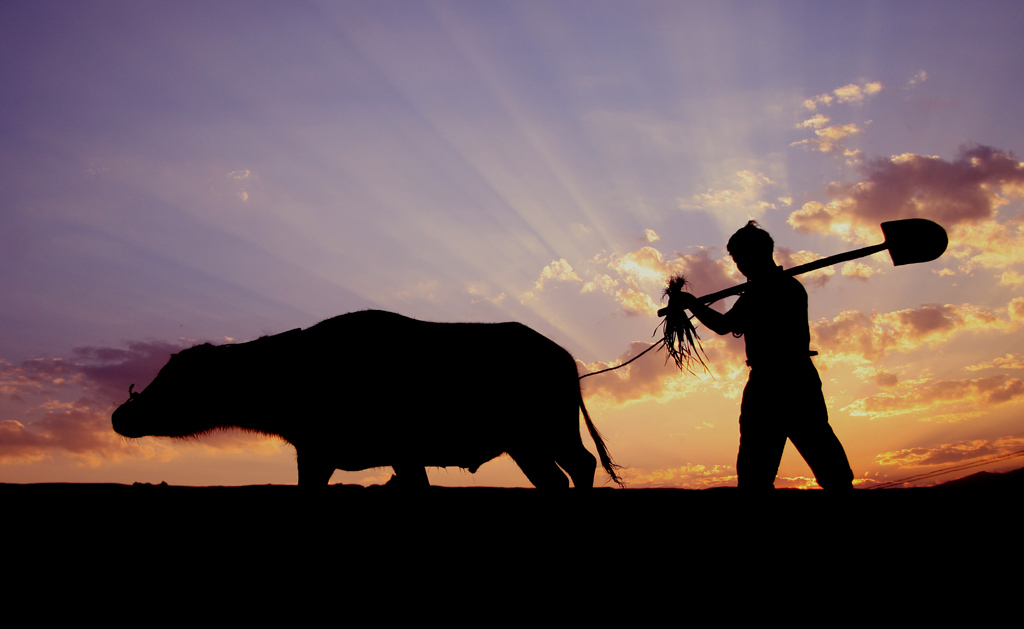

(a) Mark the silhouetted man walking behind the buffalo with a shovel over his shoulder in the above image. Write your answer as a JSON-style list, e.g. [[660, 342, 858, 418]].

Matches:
[[670, 220, 853, 490]]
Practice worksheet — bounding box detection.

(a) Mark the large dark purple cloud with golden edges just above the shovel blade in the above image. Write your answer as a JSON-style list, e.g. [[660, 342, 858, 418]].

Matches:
[[788, 146, 1024, 242]]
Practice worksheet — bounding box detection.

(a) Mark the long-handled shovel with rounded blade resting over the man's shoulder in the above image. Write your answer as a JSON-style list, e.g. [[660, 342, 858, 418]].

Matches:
[[657, 218, 949, 317]]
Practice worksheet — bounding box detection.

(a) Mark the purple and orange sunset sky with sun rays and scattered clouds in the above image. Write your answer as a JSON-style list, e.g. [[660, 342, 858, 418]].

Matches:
[[0, 0, 1024, 489]]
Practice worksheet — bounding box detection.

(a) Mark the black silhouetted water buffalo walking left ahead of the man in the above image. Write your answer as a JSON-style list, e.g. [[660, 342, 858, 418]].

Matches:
[[112, 310, 621, 488]]
